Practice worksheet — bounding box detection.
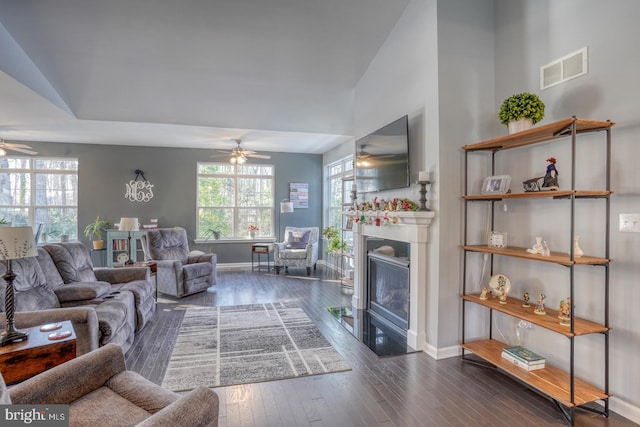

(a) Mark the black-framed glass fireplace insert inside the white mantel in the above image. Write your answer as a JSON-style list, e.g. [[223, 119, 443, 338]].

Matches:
[[367, 252, 410, 335]]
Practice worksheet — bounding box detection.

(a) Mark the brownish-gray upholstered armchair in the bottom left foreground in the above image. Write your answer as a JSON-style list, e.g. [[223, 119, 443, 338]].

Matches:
[[0, 344, 219, 427]]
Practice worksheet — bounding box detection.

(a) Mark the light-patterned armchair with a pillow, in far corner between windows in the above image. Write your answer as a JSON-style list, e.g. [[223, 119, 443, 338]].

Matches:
[[273, 227, 320, 276]]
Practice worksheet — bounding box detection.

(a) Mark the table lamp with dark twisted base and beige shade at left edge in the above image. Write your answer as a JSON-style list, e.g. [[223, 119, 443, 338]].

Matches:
[[0, 227, 38, 346]]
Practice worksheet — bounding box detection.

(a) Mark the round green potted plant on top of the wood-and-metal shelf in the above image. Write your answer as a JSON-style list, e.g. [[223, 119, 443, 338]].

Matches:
[[498, 92, 544, 133]]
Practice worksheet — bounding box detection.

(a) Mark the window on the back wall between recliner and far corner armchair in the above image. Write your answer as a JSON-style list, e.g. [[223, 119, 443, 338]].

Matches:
[[196, 163, 274, 240]]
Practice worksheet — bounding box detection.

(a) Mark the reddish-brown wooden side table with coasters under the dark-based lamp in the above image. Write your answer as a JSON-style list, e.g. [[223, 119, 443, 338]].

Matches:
[[0, 320, 76, 384]]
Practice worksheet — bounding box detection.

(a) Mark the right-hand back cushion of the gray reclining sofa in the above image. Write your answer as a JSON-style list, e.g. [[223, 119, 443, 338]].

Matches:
[[44, 242, 98, 283]]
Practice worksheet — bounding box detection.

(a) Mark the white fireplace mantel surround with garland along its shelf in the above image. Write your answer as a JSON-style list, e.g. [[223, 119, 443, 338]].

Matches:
[[345, 211, 435, 350]]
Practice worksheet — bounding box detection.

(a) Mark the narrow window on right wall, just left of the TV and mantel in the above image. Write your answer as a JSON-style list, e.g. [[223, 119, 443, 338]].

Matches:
[[325, 156, 355, 229]]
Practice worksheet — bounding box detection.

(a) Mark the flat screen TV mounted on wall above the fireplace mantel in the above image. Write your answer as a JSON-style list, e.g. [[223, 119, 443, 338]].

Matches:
[[356, 116, 409, 193]]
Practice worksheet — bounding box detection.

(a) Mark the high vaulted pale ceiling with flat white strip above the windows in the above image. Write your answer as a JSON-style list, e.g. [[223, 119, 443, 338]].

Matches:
[[0, 0, 409, 153]]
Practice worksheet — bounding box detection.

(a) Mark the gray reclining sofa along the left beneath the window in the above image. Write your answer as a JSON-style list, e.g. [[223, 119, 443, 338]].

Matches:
[[0, 242, 156, 355]]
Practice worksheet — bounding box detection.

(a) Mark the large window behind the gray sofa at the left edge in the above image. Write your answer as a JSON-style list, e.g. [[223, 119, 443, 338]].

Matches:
[[0, 157, 78, 242]]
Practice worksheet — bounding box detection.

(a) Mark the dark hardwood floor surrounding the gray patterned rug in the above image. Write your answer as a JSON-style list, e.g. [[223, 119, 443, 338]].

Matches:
[[126, 267, 636, 427]]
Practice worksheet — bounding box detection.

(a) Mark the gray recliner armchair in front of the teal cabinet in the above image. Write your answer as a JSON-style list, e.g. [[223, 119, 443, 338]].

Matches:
[[140, 228, 217, 298]]
